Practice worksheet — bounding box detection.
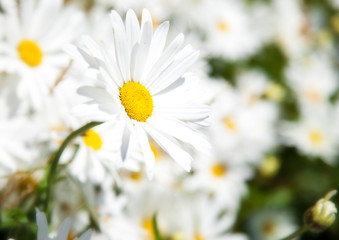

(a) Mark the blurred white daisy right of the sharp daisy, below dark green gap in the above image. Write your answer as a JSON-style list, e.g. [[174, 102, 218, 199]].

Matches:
[[208, 78, 278, 165]]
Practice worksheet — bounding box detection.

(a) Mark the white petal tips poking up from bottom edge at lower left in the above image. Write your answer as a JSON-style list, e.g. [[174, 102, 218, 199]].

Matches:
[[36, 209, 92, 240]]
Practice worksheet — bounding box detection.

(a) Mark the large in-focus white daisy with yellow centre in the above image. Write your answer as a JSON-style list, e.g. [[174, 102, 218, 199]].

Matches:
[[66, 10, 209, 177]]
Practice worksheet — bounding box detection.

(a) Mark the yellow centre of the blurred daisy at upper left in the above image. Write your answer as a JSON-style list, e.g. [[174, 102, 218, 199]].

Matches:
[[17, 39, 43, 67]]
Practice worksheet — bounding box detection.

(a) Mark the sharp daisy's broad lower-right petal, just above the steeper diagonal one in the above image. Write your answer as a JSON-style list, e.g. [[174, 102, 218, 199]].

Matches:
[[148, 117, 211, 153]]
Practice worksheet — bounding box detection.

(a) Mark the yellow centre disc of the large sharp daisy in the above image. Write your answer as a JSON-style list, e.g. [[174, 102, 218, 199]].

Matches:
[[119, 82, 153, 122]]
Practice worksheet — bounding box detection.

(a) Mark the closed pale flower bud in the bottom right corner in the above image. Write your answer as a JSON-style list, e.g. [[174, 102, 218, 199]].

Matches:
[[304, 190, 337, 232]]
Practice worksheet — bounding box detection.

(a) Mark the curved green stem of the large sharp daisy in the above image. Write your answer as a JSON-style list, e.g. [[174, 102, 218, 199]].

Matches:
[[44, 122, 102, 214]]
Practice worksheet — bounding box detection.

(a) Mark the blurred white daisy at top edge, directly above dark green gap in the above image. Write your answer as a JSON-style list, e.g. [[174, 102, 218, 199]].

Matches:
[[196, 0, 261, 60]]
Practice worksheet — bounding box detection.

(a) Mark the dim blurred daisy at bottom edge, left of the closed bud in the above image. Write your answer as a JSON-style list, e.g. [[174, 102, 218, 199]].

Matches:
[[248, 209, 298, 240]]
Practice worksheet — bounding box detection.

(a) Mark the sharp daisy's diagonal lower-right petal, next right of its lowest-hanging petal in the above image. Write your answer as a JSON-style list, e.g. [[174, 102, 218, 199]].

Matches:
[[143, 123, 192, 172]]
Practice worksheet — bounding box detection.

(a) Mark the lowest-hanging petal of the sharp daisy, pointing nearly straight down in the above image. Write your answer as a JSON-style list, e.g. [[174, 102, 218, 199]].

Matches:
[[135, 124, 155, 179]]
